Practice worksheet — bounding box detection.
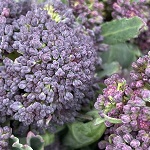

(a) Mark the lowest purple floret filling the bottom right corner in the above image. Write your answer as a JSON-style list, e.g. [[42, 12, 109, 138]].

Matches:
[[105, 127, 150, 150]]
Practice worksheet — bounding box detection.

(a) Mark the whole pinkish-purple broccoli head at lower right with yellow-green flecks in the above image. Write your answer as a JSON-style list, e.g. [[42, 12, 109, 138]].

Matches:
[[95, 53, 150, 150]]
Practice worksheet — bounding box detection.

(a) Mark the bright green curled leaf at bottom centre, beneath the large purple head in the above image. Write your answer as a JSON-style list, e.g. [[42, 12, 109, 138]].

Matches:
[[63, 110, 106, 149]]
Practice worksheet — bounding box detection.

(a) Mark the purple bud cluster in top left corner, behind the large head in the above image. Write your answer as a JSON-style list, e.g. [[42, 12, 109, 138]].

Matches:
[[0, 0, 31, 60]]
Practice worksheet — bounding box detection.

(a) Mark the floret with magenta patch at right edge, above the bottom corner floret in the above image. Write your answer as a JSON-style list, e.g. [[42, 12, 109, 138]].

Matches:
[[121, 90, 150, 131]]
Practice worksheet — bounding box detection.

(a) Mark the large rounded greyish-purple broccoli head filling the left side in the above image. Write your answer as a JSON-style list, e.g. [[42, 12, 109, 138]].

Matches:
[[0, 3, 97, 126]]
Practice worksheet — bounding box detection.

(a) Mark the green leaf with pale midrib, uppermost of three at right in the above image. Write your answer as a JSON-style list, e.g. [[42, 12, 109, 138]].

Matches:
[[101, 17, 145, 44]]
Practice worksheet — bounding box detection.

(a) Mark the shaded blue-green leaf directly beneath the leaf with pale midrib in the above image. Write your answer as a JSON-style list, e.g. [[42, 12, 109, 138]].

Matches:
[[101, 43, 141, 68]]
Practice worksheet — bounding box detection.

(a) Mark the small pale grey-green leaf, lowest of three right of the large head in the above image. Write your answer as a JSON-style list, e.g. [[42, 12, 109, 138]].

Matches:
[[98, 62, 121, 78]]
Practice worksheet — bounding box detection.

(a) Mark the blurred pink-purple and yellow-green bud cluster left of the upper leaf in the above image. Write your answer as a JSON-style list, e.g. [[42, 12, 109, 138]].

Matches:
[[68, 0, 108, 51]]
